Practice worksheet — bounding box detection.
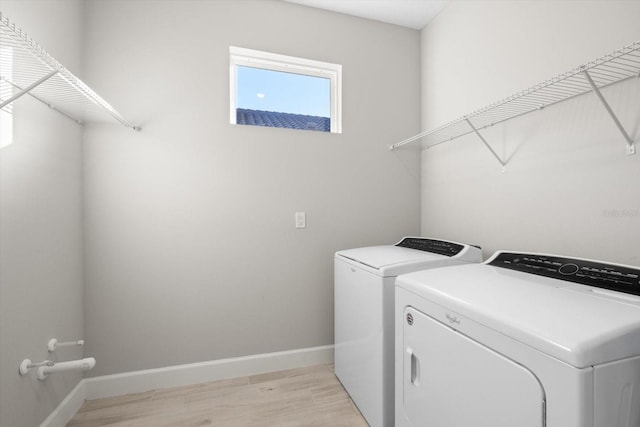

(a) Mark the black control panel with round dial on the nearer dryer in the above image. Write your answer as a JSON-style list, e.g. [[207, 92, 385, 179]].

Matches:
[[488, 252, 640, 295]]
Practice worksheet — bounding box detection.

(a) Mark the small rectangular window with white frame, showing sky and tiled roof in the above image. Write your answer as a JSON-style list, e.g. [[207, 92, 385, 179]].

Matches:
[[229, 46, 342, 133]]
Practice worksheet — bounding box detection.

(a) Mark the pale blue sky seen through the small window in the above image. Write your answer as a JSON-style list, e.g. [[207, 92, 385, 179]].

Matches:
[[236, 66, 331, 117]]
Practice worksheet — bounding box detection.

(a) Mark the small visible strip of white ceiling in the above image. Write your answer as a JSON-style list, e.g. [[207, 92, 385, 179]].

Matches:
[[285, 0, 449, 30]]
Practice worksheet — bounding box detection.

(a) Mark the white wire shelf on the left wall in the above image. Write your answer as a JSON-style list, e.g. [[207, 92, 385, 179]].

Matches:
[[0, 12, 140, 130]]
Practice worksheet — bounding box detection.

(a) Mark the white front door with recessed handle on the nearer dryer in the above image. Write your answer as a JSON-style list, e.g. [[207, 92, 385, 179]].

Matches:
[[398, 307, 545, 427]]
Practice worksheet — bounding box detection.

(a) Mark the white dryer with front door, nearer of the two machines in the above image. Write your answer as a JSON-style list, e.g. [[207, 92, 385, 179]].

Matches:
[[395, 252, 640, 427]]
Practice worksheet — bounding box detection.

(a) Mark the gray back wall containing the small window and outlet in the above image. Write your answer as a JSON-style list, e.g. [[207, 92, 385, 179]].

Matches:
[[84, 0, 420, 375]]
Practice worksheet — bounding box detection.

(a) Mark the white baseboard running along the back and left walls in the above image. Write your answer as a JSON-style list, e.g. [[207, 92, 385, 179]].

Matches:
[[40, 345, 333, 427]]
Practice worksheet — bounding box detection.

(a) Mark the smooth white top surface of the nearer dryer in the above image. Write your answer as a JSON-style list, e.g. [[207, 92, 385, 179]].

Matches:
[[396, 258, 640, 368]]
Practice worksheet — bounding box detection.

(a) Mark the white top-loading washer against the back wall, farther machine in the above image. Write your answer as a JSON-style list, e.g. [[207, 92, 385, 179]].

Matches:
[[335, 237, 482, 427]]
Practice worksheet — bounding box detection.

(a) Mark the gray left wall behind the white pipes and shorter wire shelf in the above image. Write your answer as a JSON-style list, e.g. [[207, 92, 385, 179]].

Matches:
[[0, 0, 83, 427]]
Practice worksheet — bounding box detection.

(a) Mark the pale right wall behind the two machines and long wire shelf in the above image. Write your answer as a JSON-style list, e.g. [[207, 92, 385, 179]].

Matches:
[[422, 1, 640, 265]]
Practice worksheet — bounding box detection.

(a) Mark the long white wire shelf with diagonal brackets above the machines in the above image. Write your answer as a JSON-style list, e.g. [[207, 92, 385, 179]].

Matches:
[[390, 41, 640, 161]]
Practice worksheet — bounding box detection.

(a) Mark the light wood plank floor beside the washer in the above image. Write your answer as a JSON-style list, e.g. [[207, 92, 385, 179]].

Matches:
[[67, 365, 367, 427]]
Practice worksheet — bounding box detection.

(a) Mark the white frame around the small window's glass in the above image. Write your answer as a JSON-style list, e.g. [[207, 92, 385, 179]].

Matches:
[[229, 46, 342, 133]]
